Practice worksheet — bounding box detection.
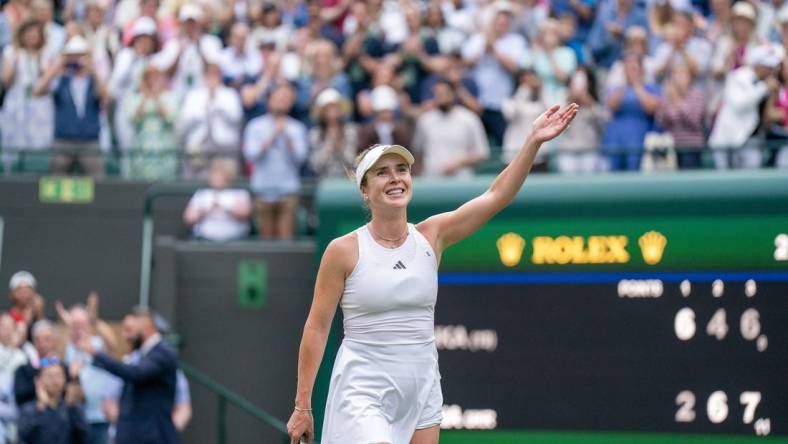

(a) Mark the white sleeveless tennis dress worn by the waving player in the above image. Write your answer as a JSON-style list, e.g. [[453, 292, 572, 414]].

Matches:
[[321, 224, 443, 444]]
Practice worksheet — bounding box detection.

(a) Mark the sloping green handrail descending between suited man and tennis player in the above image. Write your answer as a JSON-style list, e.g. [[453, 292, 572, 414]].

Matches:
[[180, 362, 304, 444]]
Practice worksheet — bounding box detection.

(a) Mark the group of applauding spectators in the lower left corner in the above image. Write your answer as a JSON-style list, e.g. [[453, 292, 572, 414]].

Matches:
[[0, 271, 192, 444]]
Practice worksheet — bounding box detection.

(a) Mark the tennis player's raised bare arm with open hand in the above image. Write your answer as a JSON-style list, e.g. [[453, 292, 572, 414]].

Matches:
[[418, 103, 578, 254]]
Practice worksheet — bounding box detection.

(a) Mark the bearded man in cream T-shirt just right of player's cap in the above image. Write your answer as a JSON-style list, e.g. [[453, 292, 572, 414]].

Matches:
[[413, 81, 490, 178]]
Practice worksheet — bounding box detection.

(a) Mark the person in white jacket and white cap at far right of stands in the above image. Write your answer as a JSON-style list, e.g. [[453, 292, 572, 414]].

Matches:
[[709, 45, 784, 169]]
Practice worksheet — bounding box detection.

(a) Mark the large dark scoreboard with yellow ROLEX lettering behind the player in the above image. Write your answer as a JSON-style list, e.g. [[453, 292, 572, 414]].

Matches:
[[316, 172, 788, 443]]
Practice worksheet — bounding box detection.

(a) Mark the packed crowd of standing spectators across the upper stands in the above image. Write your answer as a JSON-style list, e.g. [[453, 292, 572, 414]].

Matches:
[[0, 0, 788, 180]]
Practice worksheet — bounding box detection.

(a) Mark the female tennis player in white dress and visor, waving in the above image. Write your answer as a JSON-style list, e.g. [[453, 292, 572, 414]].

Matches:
[[287, 103, 578, 444]]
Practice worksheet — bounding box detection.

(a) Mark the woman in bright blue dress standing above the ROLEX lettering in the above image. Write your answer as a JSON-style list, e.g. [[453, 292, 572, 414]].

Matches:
[[602, 53, 660, 171]]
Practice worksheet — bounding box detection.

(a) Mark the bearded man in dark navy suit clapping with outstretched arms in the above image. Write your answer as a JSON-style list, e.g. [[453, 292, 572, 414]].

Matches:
[[77, 309, 180, 444]]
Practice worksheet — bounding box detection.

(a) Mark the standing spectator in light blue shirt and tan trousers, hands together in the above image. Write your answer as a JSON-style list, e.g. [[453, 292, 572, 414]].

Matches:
[[243, 84, 309, 239]]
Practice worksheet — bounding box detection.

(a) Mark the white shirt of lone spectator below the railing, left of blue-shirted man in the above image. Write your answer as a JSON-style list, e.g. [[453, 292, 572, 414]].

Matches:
[[189, 188, 251, 241]]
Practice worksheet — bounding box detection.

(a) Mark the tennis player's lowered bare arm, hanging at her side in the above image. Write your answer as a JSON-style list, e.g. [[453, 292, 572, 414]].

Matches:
[[287, 235, 358, 442]]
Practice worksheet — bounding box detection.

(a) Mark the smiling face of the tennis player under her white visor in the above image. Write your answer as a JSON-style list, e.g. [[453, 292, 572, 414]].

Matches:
[[361, 153, 413, 214]]
